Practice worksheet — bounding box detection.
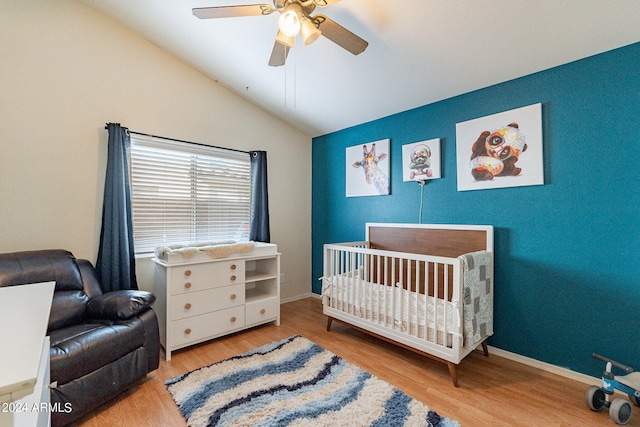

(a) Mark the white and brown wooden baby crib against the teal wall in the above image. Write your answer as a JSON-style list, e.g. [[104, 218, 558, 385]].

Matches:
[[322, 223, 493, 387]]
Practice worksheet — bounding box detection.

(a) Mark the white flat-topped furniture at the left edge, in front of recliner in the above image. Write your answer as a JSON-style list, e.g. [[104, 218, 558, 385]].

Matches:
[[0, 282, 55, 427]]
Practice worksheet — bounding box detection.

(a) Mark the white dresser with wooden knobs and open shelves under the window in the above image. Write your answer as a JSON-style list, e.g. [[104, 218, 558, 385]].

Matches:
[[153, 243, 280, 360]]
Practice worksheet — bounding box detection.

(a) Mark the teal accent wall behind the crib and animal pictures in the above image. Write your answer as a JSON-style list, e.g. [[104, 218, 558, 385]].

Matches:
[[312, 43, 640, 376]]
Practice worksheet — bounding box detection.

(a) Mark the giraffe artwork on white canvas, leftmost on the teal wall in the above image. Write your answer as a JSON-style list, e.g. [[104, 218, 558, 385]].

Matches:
[[345, 139, 391, 197]]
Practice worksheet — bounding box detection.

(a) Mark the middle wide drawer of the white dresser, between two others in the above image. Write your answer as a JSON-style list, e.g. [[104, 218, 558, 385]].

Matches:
[[170, 283, 244, 320]]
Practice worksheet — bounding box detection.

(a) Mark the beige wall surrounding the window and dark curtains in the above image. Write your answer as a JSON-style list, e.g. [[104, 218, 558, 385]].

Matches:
[[0, 0, 311, 299]]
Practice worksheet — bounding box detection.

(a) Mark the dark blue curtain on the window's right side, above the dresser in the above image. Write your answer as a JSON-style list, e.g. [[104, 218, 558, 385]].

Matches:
[[249, 151, 271, 243]]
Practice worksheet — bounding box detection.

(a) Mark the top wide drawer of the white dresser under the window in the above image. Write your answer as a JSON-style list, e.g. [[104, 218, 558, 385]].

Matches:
[[171, 260, 244, 295]]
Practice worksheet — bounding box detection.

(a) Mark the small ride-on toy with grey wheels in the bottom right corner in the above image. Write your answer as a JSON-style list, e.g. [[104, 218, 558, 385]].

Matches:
[[584, 353, 640, 424]]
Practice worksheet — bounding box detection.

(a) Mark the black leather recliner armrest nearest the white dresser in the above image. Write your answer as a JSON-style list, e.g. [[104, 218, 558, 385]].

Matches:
[[87, 290, 156, 320]]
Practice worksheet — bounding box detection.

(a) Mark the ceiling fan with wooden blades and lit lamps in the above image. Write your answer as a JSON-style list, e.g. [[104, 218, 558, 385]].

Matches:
[[193, 0, 369, 67]]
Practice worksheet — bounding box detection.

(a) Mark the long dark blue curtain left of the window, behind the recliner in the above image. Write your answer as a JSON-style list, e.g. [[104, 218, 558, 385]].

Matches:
[[96, 123, 138, 292]]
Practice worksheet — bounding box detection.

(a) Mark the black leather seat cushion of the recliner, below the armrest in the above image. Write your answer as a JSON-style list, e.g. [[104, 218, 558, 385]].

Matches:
[[50, 317, 145, 384]]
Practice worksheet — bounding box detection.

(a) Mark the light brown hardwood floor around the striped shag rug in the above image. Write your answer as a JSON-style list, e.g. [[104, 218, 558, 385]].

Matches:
[[74, 298, 624, 427]]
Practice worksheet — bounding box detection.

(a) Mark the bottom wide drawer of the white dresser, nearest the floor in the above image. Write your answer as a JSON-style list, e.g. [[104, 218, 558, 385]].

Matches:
[[170, 306, 245, 348]]
